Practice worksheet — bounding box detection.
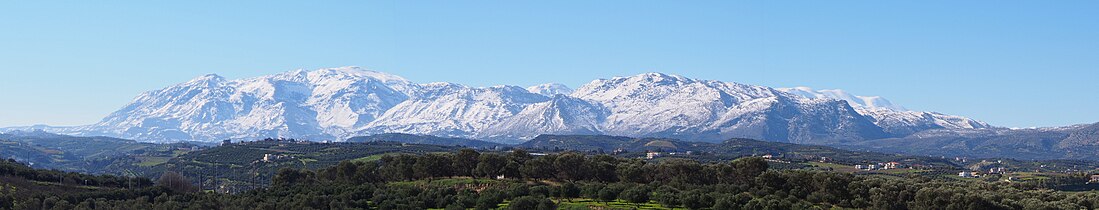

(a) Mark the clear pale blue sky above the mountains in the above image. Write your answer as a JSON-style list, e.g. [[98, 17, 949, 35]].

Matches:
[[0, 1, 1099, 126]]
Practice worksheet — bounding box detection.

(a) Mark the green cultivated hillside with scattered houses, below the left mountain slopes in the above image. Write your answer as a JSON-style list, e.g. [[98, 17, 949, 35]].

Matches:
[[129, 139, 462, 192]]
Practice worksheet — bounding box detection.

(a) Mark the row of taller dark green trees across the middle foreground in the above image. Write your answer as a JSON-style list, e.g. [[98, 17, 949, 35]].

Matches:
[[285, 150, 767, 185]]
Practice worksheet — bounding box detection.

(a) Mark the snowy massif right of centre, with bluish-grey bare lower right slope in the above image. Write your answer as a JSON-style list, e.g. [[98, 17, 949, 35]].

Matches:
[[571, 73, 882, 143]]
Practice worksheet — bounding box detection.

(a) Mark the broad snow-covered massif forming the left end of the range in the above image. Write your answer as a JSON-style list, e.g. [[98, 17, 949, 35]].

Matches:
[[80, 67, 415, 141]]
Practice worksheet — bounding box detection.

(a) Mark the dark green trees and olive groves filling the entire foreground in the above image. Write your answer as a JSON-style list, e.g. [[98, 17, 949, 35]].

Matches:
[[10, 151, 1099, 209]]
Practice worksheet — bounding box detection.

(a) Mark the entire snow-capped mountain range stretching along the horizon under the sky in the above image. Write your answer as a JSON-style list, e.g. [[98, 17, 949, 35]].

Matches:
[[0, 67, 990, 144]]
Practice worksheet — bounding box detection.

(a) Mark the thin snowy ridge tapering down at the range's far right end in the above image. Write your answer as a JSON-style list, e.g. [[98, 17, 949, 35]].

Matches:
[[778, 87, 991, 136]]
